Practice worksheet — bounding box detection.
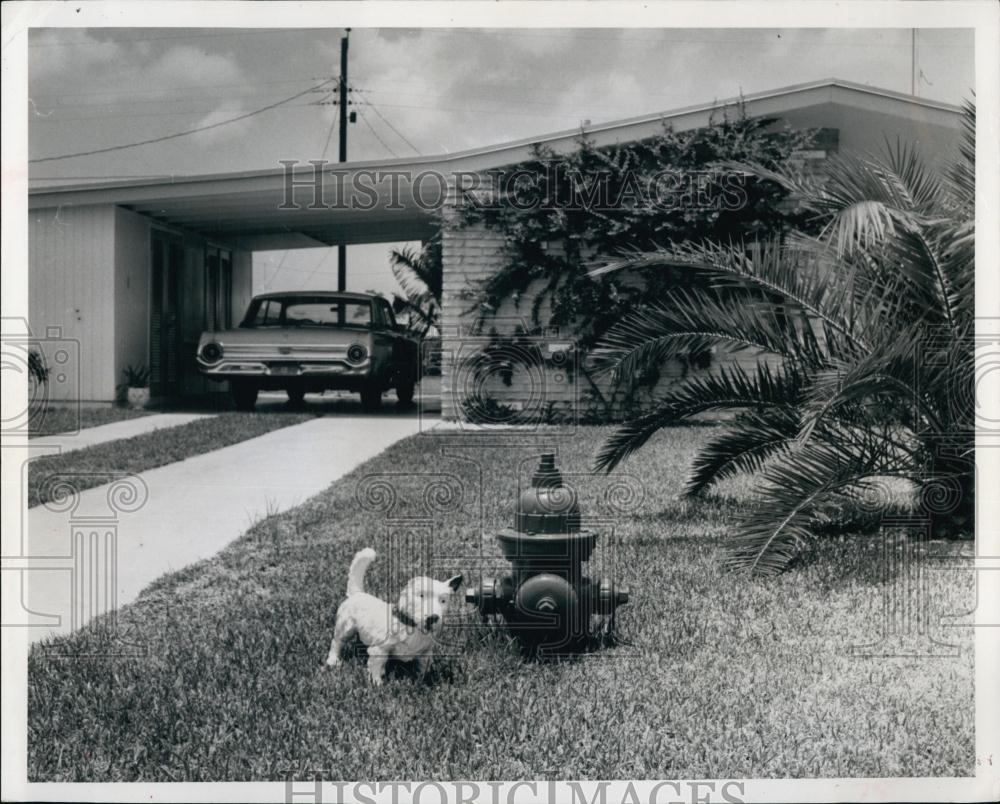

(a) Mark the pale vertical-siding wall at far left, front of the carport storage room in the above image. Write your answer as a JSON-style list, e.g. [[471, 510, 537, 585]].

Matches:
[[28, 204, 115, 401]]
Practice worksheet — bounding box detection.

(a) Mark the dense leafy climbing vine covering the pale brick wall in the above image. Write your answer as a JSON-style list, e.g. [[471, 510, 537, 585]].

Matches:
[[460, 104, 815, 351]]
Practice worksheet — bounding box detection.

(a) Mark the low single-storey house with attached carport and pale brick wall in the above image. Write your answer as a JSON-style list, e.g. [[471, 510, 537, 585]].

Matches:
[[28, 79, 961, 417]]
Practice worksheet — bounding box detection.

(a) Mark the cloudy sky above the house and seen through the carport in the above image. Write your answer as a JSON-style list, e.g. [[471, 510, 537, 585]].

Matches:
[[28, 28, 975, 292]]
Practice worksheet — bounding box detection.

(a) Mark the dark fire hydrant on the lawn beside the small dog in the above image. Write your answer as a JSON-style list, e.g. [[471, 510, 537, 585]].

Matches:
[[465, 453, 628, 654]]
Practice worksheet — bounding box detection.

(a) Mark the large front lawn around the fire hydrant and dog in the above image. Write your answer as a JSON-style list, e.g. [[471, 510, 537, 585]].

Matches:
[[28, 428, 974, 781]]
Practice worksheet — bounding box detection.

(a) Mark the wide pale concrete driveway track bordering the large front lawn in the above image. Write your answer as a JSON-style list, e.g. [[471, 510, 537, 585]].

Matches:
[[21, 415, 426, 641]]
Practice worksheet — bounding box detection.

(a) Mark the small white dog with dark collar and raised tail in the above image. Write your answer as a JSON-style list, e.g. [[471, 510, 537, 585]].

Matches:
[[326, 547, 462, 685]]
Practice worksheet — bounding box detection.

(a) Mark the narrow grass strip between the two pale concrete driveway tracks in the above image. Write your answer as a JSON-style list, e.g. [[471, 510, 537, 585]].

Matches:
[[28, 413, 312, 508]]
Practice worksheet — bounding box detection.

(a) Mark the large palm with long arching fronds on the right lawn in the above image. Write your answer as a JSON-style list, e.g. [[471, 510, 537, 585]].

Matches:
[[594, 104, 975, 573]]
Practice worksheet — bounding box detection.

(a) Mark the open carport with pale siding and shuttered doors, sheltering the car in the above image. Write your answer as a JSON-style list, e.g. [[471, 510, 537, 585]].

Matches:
[[29, 156, 448, 401]]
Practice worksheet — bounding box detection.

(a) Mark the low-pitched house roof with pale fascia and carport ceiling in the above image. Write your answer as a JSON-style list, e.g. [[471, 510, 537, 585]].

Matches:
[[29, 78, 961, 249]]
